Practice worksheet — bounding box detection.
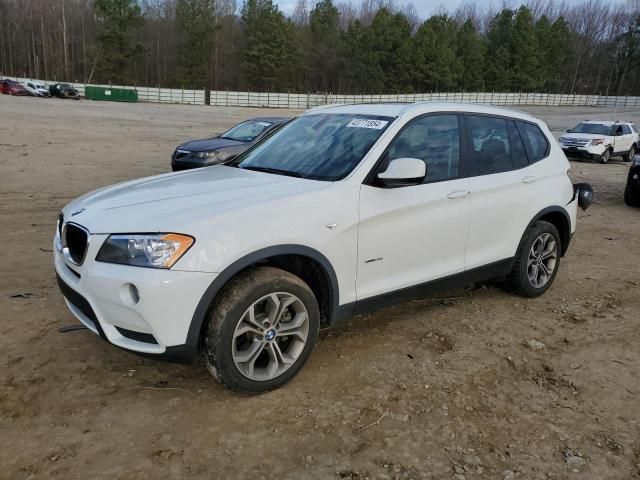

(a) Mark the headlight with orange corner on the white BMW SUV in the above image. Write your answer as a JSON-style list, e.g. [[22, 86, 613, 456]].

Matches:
[[96, 233, 195, 268]]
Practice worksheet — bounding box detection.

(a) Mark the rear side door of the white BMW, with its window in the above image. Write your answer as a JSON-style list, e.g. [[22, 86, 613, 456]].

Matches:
[[465, 115, 548, 270]]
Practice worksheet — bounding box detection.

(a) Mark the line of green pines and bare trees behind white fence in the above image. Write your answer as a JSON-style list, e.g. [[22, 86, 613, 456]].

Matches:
[[0, 0, 640, 95]]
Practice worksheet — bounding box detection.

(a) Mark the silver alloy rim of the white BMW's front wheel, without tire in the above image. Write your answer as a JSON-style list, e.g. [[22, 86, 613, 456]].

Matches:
[[232, 292, 309, 381]]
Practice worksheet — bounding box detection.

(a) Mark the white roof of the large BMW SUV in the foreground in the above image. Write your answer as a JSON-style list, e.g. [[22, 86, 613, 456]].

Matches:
[[304, 102, 537, 121]]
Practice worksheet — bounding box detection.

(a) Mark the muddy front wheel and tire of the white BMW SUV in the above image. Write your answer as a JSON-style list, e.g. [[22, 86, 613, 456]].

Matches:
[[204, 267, 320, 393]]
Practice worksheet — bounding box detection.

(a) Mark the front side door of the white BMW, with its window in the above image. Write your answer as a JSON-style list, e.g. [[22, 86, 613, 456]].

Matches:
[[356, 114, 469, 300]]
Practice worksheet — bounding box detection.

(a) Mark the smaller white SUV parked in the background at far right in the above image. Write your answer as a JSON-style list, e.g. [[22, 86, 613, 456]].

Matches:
[[560, 120, 640, 163]]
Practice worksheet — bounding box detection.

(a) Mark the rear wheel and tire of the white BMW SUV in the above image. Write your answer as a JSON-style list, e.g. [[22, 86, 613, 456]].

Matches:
[[507, 220, 561, 298]]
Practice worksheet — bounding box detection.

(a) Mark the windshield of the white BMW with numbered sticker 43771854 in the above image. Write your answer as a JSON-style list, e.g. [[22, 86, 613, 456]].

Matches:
[[232, 113, 394, 181]]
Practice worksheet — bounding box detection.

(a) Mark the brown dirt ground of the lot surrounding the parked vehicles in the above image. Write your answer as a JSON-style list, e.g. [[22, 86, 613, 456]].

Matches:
[[0, 96, 640, 480]]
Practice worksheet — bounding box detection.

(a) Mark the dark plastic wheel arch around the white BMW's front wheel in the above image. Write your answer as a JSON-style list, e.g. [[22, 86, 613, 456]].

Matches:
[[186, 244, 339, 353]]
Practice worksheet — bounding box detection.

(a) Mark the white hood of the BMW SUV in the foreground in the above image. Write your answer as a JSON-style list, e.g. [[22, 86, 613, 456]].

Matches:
[[63, 165, 330, 233]]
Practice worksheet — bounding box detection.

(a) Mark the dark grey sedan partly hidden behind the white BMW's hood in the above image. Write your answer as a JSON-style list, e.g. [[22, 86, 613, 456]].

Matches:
[[171, 117, 290, 172]]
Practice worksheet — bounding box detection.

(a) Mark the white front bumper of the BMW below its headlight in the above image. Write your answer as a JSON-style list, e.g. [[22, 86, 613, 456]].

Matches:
[[54, 231, 216, 361]]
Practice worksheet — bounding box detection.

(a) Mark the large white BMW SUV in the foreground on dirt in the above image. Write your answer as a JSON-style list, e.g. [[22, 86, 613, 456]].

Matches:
[[54, 103, 592, 392]]
